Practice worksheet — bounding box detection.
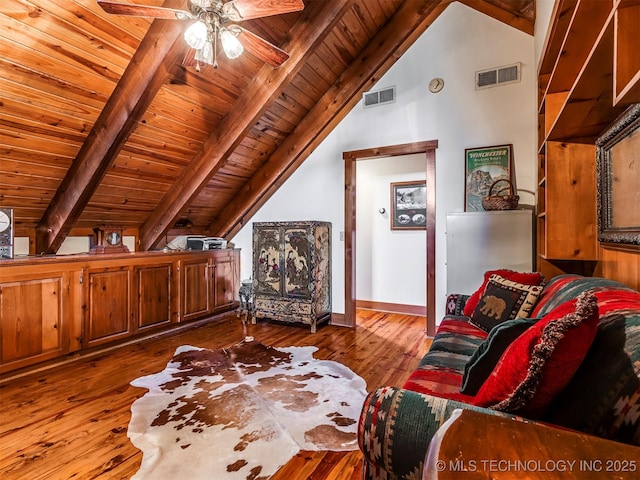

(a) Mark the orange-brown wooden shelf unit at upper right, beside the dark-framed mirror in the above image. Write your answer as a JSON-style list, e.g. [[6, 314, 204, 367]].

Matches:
[[537, 0, 640, 276]]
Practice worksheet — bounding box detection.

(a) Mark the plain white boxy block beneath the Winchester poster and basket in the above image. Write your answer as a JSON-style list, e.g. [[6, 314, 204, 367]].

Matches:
[[447, 210, 535, 295]]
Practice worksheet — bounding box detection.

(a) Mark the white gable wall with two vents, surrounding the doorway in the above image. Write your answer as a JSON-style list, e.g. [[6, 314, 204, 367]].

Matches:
[[233, 3, 537, 321]]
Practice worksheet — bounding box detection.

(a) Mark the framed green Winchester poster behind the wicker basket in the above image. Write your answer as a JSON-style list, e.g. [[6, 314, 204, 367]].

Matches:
[[464, 144, 515, 212]]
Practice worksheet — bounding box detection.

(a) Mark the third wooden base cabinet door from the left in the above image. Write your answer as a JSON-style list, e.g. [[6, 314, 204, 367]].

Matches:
[[135, 263, 173, 330]]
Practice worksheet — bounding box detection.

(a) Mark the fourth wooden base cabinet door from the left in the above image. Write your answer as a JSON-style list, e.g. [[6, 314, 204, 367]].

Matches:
[[181, 258, 213, 321]]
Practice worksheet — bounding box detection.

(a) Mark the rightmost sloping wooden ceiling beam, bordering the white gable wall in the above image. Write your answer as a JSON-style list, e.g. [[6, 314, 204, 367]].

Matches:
[[209, 0, 449, 237]]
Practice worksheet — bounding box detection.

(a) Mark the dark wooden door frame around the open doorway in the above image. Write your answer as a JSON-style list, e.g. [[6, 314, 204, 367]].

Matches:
[[342, 140, 438, 336]]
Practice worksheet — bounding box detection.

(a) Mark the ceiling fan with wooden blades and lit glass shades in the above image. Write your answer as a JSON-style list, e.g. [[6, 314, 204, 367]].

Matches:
[[97, 0, 304, 71]]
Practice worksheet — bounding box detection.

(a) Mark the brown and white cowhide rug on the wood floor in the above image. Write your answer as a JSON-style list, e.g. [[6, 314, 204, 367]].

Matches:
[[128, 342, 366, 480]]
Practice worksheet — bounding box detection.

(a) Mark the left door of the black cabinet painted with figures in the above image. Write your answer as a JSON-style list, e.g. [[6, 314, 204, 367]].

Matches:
[[253, 226, 282, 296]]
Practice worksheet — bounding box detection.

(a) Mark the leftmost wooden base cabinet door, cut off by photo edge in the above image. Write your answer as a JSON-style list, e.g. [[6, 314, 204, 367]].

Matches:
[[0, 273, 70, 372]]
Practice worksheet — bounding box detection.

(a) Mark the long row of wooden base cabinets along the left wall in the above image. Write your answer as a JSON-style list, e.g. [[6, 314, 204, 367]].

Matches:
[[0, 249, 240, 373]]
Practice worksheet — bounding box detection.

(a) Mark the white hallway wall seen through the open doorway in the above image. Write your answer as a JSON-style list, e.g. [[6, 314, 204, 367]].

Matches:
[[356, 155, 429, 306]]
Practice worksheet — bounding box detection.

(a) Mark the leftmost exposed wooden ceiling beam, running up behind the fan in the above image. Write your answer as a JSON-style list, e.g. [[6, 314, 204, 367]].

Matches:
[[36, 14, 185, 254]]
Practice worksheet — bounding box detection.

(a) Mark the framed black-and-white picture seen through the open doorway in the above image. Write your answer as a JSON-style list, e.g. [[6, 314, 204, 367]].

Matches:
[[391, 180, 427, 230]]
